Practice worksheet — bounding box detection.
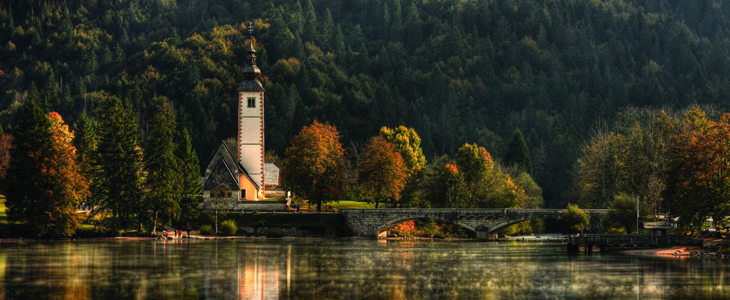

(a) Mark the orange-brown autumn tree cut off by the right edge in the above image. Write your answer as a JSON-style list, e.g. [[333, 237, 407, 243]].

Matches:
[[664, 110, 730, 230]]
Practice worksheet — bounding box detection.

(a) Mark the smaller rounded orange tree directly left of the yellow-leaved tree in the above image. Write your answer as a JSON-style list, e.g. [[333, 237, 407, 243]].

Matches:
[[358, 136, 408, 208]]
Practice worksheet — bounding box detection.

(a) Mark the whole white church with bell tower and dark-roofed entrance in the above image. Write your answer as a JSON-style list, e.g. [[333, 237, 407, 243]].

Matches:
[[201, 26, 286, 211]]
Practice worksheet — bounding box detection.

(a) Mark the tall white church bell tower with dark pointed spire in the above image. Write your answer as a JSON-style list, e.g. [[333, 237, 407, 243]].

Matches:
[[237, 23, 265, 199]]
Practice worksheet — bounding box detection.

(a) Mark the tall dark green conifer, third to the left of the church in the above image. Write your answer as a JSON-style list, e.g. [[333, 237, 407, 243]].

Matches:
[[92, 97, 148, 229]]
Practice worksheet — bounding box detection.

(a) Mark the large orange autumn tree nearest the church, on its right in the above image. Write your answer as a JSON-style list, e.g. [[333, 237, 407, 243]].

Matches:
[[282, 121, 346, 211]]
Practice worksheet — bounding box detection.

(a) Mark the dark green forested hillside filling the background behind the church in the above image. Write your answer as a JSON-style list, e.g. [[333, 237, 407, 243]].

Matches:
[[0, 0, 730, 207]]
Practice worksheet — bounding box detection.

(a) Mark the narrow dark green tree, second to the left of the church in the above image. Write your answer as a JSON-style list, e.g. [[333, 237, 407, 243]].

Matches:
[[145, 97, 183, 233]]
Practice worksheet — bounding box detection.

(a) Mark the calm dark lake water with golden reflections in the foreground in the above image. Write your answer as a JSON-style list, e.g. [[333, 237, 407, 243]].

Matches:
[[0, 240, 730, 299]]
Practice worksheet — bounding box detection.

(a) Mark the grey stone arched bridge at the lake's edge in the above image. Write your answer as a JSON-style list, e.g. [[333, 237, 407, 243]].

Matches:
[[339, 208, 608, 240]]
